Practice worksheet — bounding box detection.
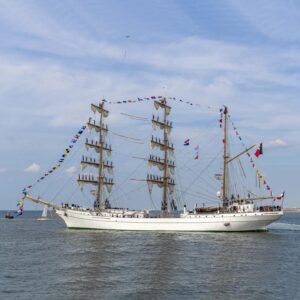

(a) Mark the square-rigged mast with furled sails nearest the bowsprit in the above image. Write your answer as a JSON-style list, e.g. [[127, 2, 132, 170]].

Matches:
[[77, 102, 114, 210]]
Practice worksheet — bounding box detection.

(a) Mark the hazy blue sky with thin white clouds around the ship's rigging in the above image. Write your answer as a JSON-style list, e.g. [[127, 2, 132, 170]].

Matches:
[[0, 0, 300, 209]]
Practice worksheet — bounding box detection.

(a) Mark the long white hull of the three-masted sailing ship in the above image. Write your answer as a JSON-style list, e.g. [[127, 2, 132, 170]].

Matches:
[[56, 208, 282, 232]]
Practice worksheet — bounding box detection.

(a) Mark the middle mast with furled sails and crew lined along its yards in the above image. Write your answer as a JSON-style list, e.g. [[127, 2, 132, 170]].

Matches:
[[147, 98, 177, 216]]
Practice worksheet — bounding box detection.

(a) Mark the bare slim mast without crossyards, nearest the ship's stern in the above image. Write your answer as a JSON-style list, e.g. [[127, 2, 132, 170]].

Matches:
[[222, 106, 229, 207]]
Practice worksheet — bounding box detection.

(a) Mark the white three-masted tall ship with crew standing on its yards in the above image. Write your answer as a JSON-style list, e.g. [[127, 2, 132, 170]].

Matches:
[[24, 98, 283, 232]]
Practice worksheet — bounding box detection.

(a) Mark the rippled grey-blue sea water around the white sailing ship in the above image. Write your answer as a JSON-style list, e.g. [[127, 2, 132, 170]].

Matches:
[[0, 212, 300, 300]]
